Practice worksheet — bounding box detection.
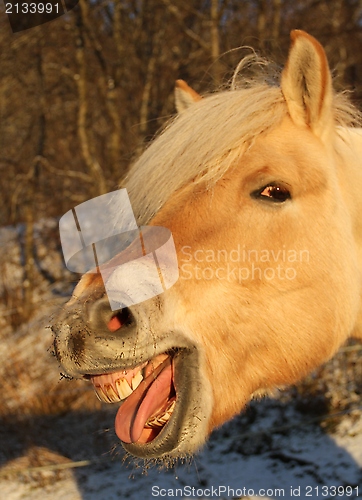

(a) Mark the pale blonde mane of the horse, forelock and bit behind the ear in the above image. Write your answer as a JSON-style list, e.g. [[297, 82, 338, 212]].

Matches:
[[123, 56, 358, 225]]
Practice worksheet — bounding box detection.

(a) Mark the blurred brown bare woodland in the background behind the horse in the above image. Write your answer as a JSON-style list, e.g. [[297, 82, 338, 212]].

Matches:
[[0, 0, 362, 229]]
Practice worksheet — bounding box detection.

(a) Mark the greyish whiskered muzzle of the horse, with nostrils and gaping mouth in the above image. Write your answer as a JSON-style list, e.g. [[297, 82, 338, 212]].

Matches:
[[52, 295, 211, 458]]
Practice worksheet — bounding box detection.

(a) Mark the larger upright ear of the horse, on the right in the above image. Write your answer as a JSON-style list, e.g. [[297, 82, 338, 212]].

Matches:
[[281, 30, 333, 138]]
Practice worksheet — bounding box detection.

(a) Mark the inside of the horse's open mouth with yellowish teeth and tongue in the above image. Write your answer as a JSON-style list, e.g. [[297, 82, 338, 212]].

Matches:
[[90, 353, 177, 444]]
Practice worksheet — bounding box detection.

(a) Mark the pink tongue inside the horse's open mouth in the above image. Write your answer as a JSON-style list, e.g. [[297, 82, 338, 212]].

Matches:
[[115, 358, 172, 443]]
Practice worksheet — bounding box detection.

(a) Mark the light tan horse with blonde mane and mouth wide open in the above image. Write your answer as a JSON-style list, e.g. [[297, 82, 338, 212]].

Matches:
[[53, 30, 362, 460]]
